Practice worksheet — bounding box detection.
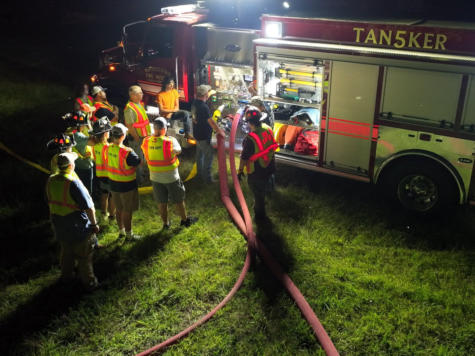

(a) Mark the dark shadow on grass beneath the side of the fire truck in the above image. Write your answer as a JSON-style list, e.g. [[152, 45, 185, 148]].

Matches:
[[272, 166, 475, 250]]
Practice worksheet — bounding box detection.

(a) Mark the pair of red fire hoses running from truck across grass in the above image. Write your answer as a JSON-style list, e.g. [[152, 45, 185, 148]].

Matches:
[[137, 111, 339, 356]]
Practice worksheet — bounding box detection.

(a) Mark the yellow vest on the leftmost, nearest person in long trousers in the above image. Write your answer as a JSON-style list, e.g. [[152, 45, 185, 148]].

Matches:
[[46, 172, 80, 216]]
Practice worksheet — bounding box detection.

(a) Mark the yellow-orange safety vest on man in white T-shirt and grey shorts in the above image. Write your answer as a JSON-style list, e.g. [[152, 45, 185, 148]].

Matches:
[[142, 136, 180, 172]]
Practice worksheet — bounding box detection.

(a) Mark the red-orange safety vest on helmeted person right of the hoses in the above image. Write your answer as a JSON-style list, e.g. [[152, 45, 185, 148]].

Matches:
[[246, 124, 279, 174]]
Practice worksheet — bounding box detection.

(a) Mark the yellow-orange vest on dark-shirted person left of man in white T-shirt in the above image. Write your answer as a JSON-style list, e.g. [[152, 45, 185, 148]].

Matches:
[[102, 143, 137, 183]]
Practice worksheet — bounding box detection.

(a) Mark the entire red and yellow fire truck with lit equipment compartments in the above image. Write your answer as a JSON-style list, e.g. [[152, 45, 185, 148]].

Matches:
[[92, 2, 475, 213]]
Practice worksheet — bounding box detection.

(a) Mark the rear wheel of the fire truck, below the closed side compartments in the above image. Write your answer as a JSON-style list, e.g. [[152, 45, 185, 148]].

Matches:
[[389, 161, 457, 214]]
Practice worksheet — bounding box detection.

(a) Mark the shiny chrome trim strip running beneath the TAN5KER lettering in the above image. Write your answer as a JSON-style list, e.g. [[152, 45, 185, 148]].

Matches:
[[253, 38, 475, 64]]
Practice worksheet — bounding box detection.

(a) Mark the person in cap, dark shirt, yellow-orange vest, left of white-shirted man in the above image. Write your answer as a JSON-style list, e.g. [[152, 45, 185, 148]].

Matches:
[[103, 124, 141, 240]]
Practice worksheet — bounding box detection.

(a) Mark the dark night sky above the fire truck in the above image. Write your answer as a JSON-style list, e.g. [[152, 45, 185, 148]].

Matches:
[[0, 0, 475, 82]]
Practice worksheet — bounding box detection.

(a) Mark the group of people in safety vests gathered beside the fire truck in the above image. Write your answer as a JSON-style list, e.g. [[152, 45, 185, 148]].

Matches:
[[46, 78, 278, 290]]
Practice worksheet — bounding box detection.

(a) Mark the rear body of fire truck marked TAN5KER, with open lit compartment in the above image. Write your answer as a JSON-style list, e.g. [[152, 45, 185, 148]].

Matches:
[[254, 15, 475, 211]]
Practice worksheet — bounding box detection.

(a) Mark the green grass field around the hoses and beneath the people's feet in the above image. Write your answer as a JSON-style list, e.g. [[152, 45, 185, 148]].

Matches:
[[0, 46, 475, 355]]
